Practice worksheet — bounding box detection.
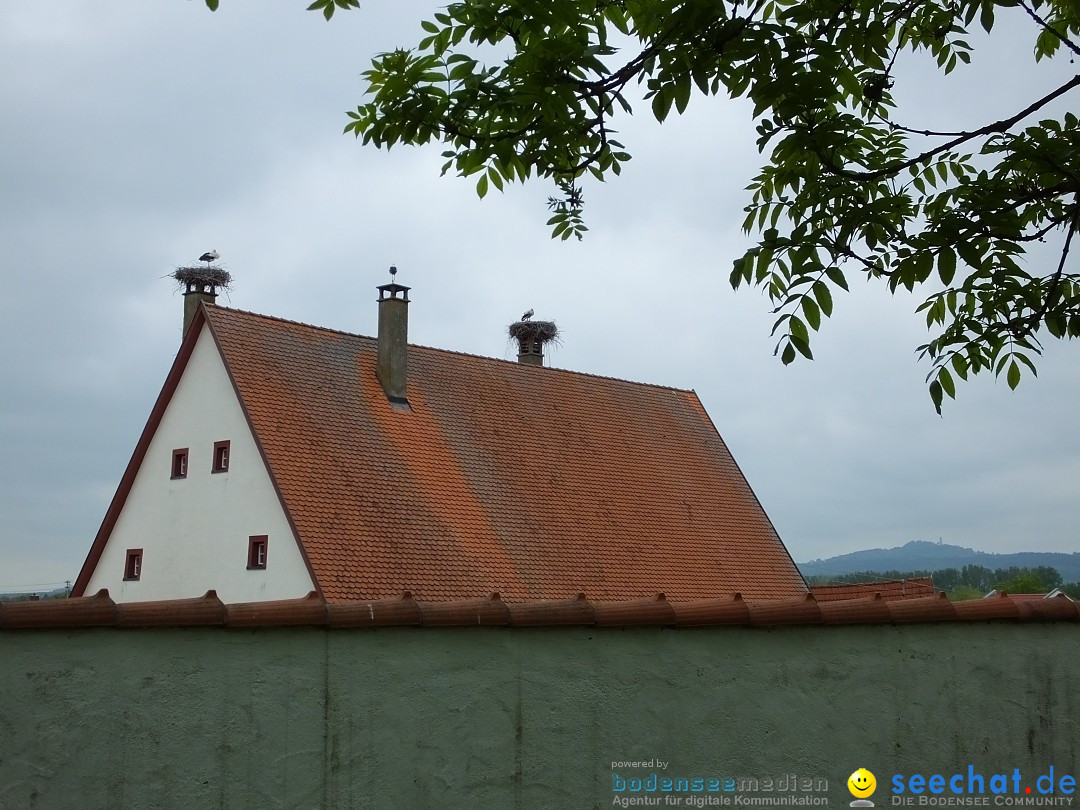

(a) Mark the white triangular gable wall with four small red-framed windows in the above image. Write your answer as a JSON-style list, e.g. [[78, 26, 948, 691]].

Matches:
[[85, 325, 314, 603]]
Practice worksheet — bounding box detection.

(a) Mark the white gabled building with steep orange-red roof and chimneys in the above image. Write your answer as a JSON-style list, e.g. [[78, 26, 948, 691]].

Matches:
[[72, 283, 807, 603]]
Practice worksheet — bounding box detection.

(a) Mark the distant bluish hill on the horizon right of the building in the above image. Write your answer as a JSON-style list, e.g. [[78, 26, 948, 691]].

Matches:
[[797, 540, 1080, 582]]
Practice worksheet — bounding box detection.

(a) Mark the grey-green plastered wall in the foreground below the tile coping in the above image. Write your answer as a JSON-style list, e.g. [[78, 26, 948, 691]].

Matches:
[[0, 623, 1080, 810]]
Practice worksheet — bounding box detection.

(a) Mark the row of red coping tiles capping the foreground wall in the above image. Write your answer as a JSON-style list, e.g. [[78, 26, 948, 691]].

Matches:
[[6, 591, 1080, 631]]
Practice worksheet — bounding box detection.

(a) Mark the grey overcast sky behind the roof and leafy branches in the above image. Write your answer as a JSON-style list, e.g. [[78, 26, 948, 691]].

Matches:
[[0, 0, 1080, 592]]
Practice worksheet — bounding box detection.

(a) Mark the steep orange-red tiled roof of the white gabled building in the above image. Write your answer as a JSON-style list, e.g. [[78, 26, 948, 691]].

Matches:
[[204, 307, 806, 602]]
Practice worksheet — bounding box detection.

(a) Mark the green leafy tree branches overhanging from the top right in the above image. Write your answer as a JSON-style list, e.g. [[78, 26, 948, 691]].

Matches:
[[206, 0, 1080, 413]]
